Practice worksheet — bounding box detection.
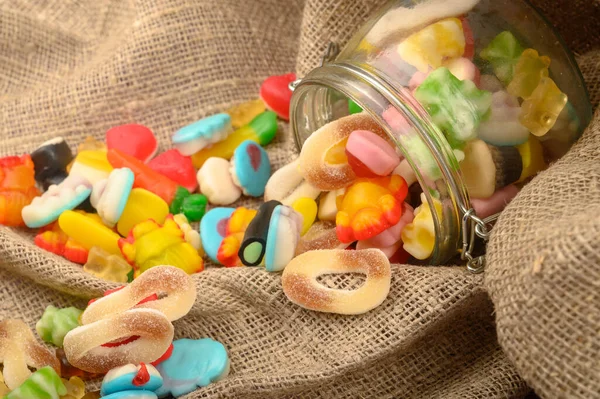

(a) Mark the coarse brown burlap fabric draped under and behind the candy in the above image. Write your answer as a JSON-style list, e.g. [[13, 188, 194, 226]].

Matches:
[[0, 0, 599, 398]]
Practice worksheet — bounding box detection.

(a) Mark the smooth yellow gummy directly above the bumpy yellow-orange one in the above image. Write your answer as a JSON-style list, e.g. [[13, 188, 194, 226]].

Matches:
[[117, 188, 169, 237]]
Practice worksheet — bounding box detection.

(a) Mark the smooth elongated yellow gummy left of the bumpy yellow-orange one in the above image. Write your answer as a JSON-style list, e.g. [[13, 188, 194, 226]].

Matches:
[[58, 211, 121, 255]]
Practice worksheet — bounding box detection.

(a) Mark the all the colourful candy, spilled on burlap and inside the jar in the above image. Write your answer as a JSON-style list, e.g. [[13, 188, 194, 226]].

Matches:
[[0, 10, 577, 399]]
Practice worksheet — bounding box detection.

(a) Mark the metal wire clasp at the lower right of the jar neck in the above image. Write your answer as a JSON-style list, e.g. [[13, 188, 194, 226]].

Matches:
[[460, 208, 499, 274]]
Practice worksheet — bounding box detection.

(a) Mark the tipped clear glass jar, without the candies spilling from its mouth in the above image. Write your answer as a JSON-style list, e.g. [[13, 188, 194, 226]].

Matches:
[[290, 0, 592, 271]]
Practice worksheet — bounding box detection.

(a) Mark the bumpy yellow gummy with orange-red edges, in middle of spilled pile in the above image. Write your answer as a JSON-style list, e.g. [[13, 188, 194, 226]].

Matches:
[[119, 215, 204, 274]]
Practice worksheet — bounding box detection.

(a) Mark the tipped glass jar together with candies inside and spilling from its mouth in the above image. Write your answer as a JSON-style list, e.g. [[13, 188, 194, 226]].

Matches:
[[290, 0, 591, 264]]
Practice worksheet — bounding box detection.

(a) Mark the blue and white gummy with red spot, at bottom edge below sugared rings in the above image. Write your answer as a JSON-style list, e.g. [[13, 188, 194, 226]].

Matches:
[[100, 363, 163, 399]]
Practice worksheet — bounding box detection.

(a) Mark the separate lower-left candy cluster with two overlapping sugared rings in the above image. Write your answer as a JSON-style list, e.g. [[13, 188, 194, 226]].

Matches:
[[0, 266, 229, 399]]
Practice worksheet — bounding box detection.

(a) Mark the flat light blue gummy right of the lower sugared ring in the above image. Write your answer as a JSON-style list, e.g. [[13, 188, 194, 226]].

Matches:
[[156, 338, 229, 398]]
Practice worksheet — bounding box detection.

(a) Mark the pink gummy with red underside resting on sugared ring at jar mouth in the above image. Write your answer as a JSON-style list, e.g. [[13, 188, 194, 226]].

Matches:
[[346, 130, 400, 177]]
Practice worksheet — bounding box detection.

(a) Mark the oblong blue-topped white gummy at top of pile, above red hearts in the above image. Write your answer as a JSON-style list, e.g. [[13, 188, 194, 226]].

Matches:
[[171, 114, 233, 156]]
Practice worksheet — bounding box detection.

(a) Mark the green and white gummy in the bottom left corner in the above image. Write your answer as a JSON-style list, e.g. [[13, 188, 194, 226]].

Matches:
[[4, 366, 67, 399]]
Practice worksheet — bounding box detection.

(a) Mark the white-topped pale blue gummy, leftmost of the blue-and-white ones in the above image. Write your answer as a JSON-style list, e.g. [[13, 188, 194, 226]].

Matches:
[[21, 176, 92, 228]]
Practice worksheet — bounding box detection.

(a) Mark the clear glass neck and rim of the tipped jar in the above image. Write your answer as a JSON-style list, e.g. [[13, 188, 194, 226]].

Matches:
[[290, 63, 470, 264]]
